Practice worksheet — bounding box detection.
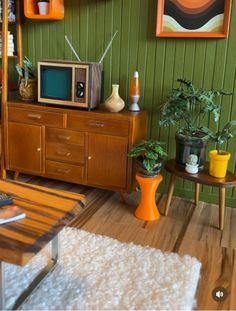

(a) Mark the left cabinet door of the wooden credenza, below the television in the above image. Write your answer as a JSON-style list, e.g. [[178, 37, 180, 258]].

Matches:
[[7, 122, 42, 173]]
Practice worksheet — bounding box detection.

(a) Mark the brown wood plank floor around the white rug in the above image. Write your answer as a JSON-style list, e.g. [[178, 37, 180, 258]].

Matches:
[[15, 175, 236, 310]]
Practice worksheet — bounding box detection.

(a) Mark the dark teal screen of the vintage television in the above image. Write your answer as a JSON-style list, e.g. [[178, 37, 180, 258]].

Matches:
[[41, 66, 72, 101]]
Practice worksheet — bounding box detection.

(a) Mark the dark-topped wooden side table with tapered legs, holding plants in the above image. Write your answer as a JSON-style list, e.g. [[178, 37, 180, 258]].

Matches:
[[164, 159, 236, 230]]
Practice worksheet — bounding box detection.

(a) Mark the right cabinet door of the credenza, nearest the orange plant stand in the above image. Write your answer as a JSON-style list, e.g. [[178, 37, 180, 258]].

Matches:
[[88, 134, 128, 188]]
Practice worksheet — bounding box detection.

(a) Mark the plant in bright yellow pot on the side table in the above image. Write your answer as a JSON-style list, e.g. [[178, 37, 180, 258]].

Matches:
[[209, 121, 236, 178]]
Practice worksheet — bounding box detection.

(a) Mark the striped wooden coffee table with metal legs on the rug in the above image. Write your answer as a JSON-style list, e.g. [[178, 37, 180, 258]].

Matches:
[[0, 180, 84, 310]]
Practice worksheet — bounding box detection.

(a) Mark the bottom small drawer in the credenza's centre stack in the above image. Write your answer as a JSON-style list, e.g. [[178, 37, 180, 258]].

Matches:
[[45, 160, 84, 183]]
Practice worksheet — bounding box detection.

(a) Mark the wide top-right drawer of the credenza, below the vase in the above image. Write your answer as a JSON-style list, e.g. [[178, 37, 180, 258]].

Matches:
[[67, 114, 129, 136]]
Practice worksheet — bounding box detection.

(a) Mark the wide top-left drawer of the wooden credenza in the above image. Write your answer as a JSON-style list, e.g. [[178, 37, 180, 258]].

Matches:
[[8, 107, 63, 127]]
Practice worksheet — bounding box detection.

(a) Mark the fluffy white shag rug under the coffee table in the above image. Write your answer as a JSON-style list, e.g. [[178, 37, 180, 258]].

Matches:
[[5, 228, 201, 310]]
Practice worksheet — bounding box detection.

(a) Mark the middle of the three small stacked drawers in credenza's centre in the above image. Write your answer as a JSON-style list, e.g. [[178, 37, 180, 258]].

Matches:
[[46, 142, 84, 164]]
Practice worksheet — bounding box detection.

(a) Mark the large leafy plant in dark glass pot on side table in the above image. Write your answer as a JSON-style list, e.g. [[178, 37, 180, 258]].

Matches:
[[159, 79, 231, 166]]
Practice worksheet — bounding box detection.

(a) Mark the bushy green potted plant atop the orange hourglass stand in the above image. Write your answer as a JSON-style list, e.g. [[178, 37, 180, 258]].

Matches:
[[128, 139, 167, 177]]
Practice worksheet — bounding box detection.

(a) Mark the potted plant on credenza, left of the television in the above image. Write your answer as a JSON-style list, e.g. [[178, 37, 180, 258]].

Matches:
[[16, 56, 37, 101]]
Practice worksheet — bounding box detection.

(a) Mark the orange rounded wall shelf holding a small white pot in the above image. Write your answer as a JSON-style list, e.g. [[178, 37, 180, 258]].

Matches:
[[24, 0, 64, 20]]
